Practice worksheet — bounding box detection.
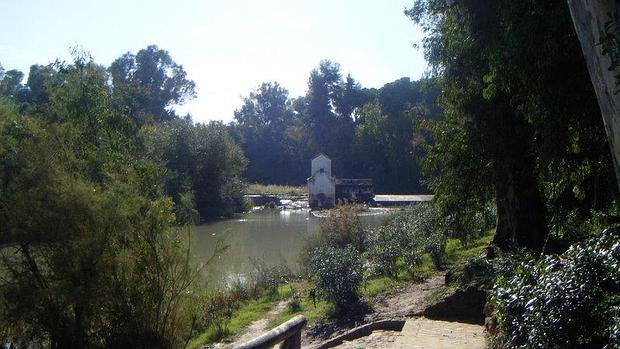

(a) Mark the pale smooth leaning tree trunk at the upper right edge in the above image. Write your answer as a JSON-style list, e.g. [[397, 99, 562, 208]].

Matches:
[[568, 0, 620, 189]]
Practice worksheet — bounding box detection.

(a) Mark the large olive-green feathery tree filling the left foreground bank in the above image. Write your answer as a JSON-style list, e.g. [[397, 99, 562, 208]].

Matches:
[[0, 56, 198, 348]]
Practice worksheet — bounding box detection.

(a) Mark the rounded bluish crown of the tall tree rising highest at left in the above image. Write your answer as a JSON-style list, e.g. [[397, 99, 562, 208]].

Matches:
[[108, 45, 196, 125]]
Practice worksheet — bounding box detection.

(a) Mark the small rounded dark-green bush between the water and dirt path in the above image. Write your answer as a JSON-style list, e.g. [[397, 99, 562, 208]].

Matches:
[[310, 246, 363, 313]]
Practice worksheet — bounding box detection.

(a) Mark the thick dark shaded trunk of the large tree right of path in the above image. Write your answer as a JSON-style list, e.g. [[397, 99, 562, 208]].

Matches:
[[484, 94, 549, 252]]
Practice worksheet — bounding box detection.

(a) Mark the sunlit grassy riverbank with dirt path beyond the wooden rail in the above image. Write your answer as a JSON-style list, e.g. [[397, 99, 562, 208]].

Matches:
[[188, 231, 492, 348]]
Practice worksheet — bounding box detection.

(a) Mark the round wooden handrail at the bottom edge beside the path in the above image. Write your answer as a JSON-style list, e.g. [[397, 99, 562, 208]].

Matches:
[[235, 315, 306, 349]]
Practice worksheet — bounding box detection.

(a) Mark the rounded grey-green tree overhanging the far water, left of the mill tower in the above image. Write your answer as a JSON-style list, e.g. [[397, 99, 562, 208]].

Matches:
[[142, 119, 246, 223]]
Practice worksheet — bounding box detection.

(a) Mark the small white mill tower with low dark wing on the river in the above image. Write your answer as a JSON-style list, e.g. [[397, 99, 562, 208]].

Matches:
[[308, 154, 375, 208]]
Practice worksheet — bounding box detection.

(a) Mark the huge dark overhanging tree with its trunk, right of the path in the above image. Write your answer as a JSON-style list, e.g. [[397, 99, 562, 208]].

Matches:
[[408, 0, 606, 250]]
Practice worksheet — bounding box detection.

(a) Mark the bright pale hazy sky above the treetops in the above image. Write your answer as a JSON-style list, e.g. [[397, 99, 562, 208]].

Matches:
[[0, 0, 426, 122]]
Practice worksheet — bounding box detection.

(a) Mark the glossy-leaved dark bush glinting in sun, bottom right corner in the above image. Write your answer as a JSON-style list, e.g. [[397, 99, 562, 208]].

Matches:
[[490, 231, 620, 348]]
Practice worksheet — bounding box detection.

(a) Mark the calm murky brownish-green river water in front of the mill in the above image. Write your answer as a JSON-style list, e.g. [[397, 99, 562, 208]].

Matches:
[[190, 209, 386, 286]]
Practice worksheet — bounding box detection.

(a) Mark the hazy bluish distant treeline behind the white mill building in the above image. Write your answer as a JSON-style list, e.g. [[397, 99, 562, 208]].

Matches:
[[229, 60, 442, 192]]
